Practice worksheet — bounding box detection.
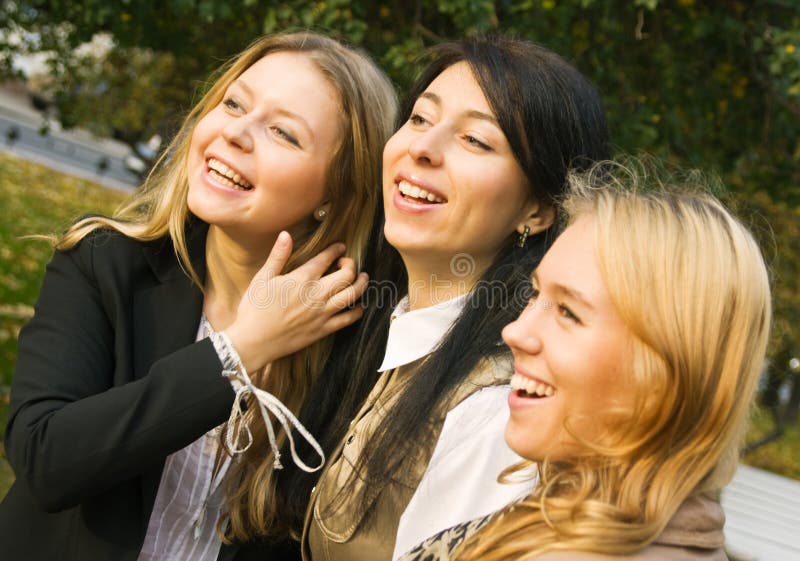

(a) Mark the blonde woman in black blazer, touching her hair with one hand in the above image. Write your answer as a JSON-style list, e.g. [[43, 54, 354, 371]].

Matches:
[[0, 32, 396, 561]]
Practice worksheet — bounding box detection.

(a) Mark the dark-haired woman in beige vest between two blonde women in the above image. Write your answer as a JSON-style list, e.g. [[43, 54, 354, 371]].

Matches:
[[284, 37, 608, 561]]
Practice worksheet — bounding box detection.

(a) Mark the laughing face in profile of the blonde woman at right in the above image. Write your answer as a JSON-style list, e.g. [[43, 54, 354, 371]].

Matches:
[[503, 216, 634, 461]]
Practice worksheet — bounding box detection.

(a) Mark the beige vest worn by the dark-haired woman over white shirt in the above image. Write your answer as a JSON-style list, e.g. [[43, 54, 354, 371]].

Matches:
[[302, 356, 513, 561]]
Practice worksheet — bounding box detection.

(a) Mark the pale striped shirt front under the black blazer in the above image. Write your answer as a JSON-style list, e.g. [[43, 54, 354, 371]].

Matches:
[[137, 324, 230, 561]]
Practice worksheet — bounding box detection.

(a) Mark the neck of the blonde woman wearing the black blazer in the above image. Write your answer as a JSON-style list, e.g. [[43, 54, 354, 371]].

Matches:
[[203, 225, 277, 331]]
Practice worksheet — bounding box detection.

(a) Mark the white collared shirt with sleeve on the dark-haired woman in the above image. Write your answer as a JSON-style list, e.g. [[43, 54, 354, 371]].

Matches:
[[380, 295, 535, 560]]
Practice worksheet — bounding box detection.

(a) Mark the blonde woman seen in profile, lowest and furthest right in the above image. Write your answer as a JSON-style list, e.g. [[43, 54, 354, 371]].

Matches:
[[402, 160, 770, 561]]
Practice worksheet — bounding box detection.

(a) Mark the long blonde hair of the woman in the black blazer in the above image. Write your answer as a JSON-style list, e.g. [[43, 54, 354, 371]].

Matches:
[[55, 32, 397, 540]]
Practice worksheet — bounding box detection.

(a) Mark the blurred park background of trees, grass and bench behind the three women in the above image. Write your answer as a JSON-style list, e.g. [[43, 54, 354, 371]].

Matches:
[[0, 0, 800, 561]]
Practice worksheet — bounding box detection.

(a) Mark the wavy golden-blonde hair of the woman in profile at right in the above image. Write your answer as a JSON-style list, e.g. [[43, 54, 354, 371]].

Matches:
[[454, 160, 771, 561]]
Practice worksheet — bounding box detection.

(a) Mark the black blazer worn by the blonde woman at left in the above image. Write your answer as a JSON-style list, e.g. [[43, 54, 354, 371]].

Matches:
[[0, 224, 294, 561]]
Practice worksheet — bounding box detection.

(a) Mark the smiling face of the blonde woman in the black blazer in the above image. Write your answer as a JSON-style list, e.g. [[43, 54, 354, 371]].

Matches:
[[188, 51, 341, 243]]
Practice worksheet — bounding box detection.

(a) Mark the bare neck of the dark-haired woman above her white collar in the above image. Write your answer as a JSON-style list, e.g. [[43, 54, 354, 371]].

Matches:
[[403, 255, 484, 310]]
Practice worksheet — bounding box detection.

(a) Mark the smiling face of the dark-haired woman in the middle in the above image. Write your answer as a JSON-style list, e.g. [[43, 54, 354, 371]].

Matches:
[[383, 62, 536, 284]]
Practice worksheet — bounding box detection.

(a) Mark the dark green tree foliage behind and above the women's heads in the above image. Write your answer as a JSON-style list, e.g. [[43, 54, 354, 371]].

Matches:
[[0, 0, 800, 199]]
